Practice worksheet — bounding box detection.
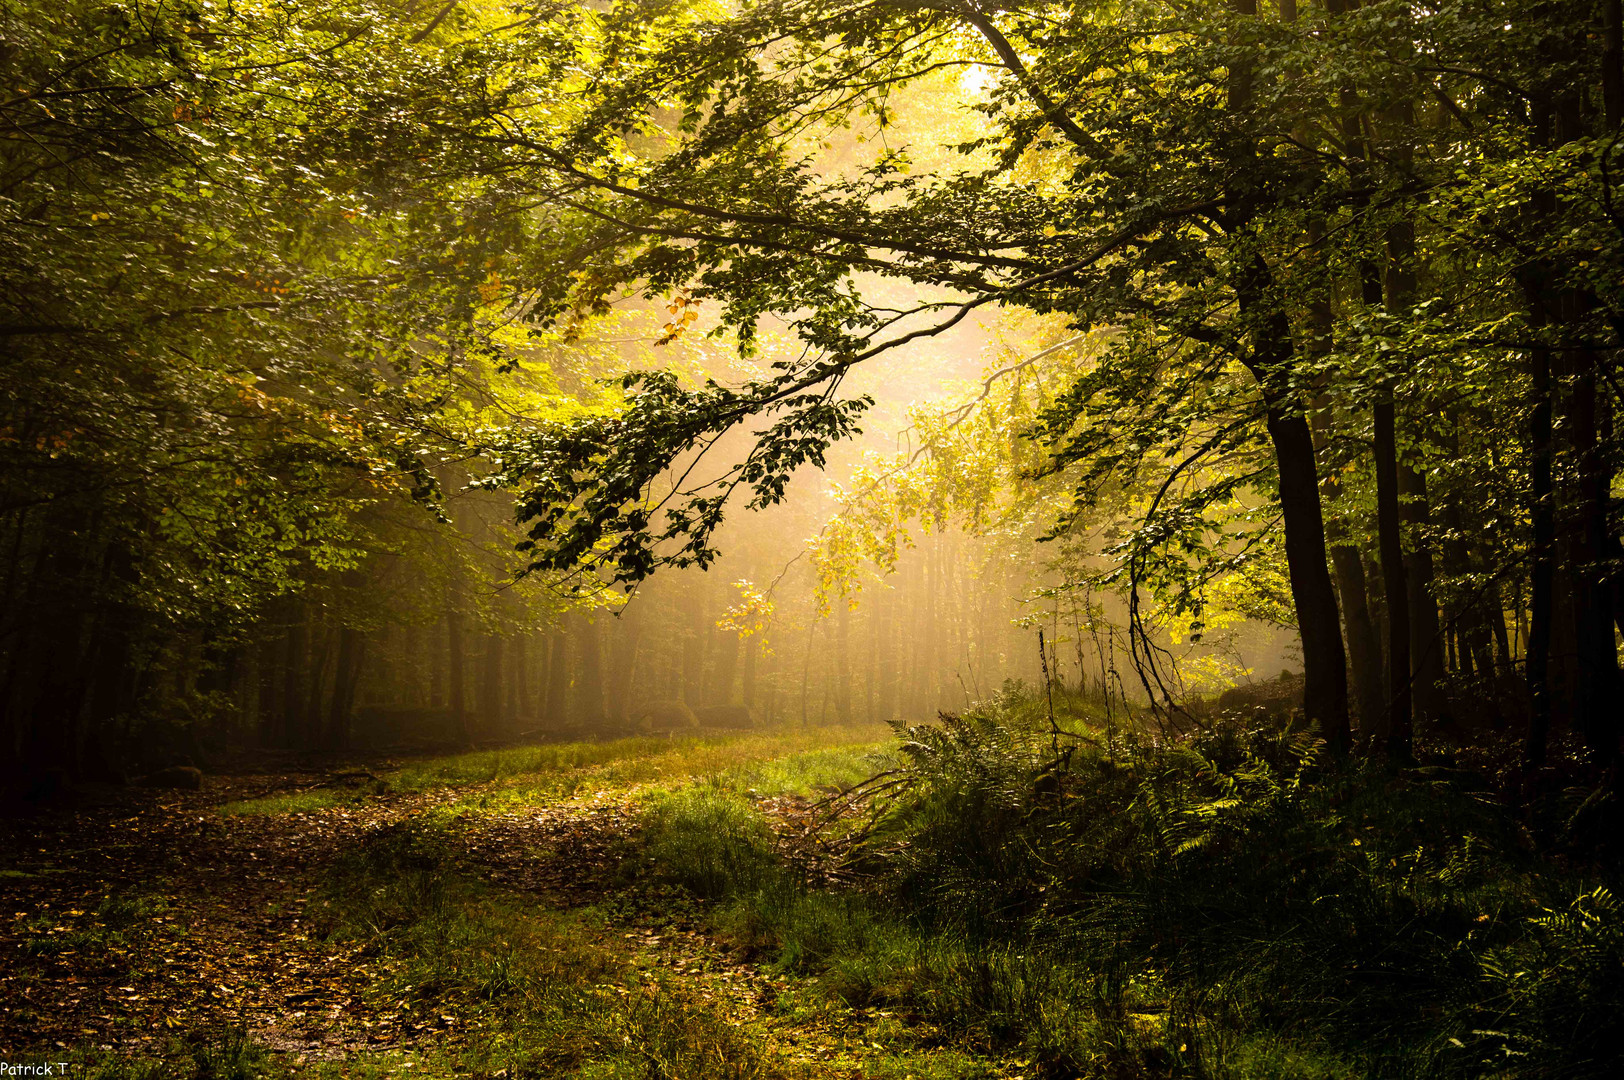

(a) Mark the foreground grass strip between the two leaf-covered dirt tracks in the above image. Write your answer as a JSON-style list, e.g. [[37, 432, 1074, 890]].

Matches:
[[313, 823, 784, 1080]]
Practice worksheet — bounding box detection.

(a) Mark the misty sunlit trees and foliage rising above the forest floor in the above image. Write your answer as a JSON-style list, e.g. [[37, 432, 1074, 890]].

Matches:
[[0, 0, 1624, 778]]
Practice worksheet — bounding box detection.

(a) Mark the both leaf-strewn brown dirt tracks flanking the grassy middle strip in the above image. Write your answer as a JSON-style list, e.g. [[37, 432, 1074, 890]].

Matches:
[[0, 773, 902, 1064]]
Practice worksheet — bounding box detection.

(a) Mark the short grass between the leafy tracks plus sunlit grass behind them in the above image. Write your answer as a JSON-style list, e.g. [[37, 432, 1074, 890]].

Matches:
[[184, 726, 1018, 1080]]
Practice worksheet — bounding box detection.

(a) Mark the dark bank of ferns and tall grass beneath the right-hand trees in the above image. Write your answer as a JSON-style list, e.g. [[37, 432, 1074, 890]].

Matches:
[[648, 695, 1624, 1078]]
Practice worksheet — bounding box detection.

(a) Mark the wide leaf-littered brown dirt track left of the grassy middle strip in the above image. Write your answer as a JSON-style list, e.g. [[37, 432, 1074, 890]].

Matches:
[[0, 775, 422, 1051]]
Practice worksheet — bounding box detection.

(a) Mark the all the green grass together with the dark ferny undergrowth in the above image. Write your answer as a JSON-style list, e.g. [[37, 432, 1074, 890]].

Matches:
[[98, 704, 1624, 1080]]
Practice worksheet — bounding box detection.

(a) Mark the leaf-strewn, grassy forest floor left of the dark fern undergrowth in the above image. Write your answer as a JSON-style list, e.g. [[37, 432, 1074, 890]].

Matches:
[[0, 728, 1023, 1080]]
